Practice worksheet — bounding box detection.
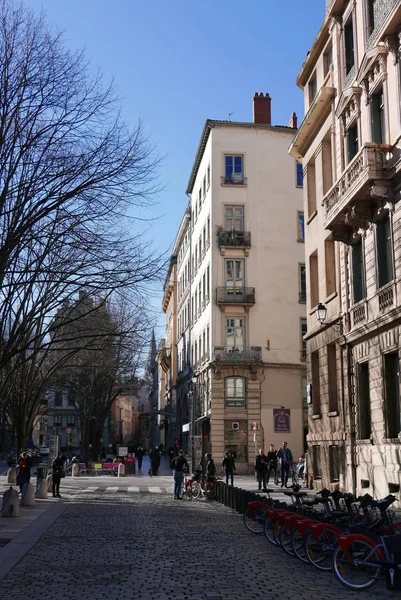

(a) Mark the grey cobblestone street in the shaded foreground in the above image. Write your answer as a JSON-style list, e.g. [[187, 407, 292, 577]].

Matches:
[[0, 490, 399, 600]]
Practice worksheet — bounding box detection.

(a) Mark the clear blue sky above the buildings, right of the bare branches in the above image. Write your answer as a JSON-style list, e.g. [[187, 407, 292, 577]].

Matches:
[[25, 0, 325, 334]]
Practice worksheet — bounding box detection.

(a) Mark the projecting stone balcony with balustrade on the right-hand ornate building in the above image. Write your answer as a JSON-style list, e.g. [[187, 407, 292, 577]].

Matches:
[[322, 143, 392, 237]]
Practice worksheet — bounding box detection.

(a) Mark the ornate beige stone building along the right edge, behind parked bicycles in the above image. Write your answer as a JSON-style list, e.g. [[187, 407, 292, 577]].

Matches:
[[290, 0, 401, 497]]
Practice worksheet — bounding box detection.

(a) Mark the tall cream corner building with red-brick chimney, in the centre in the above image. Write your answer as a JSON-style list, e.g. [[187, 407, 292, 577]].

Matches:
[[163, 94, 306, 472]]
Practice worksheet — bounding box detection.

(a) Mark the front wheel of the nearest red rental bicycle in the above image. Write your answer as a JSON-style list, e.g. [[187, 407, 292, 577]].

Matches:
[[333, 540, 382, 590]]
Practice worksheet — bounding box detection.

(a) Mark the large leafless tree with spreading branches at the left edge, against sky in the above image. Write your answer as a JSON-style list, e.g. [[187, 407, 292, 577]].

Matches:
[[0, 0, 166, 440]]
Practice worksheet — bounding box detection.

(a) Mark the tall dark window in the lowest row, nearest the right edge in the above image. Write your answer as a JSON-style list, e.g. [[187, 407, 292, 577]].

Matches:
[[384, 352, 401, 438]]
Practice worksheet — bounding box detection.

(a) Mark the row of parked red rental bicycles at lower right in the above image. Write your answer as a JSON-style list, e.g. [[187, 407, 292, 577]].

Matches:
[[243, 486, 401, 591]]
